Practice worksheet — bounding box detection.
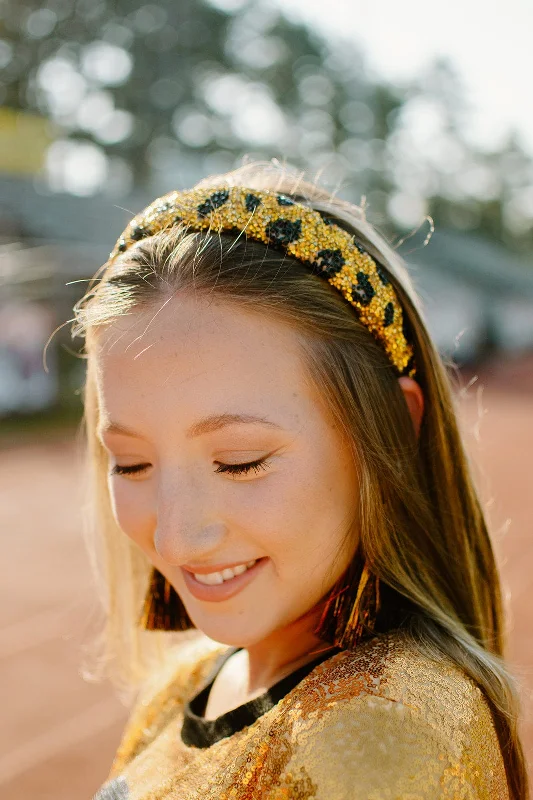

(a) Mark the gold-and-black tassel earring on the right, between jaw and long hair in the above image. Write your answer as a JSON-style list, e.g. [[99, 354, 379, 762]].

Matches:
[[316, 560, 380, 650]]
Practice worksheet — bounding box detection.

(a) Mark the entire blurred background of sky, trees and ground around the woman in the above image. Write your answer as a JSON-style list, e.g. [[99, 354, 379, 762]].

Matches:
[[0, 0, 533, 800]]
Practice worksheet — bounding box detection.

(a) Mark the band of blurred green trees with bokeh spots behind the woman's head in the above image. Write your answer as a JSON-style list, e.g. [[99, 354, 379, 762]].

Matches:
[[0, 0, 533, 249]]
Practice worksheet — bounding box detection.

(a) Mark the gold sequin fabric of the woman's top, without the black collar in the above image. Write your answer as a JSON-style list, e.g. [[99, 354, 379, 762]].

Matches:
[[96, 633, 509, 800]]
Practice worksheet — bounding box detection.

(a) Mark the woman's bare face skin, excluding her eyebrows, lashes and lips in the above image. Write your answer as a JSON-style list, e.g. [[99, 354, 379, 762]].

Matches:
[[91, 295, 358, 686]]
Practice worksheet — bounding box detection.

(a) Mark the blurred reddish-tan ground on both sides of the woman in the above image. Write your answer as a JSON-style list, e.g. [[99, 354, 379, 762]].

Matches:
[[0, 359, 533, 800]]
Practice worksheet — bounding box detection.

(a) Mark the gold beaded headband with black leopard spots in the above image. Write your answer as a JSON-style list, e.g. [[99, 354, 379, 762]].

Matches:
[[108, 186, 415, 377]]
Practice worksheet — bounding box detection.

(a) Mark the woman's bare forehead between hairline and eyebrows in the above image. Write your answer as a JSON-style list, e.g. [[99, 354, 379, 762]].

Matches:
[[90, 295, 314, 428]]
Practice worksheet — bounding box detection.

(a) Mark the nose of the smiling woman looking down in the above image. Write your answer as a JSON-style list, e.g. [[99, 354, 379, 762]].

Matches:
[[153, 475, 226, 566]]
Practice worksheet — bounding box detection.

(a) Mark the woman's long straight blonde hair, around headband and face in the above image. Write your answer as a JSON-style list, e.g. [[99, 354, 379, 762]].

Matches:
[[73, 159, 527, 800]]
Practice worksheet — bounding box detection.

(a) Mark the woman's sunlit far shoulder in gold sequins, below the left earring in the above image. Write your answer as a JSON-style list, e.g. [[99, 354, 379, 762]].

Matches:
[[110, 633, 227, 777]]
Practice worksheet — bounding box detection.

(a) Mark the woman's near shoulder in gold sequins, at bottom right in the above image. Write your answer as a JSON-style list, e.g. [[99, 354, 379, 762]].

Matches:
[[278, 634, 508, 800]]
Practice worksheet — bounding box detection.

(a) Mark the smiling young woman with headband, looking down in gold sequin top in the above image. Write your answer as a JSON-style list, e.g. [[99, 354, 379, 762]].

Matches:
[[79, 159, 527, 800]]
